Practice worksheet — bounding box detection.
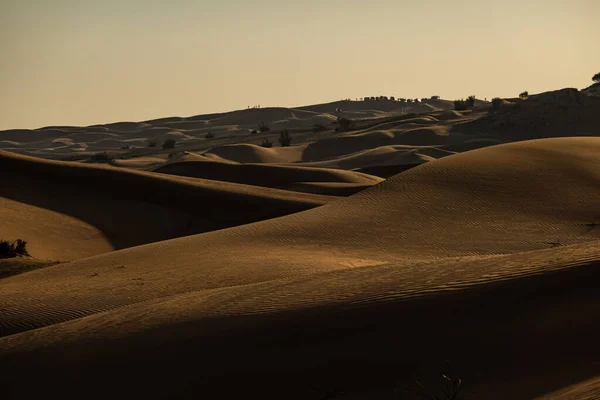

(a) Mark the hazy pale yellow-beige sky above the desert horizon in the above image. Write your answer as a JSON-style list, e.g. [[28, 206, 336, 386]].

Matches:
[[0, 0, 600, 129]]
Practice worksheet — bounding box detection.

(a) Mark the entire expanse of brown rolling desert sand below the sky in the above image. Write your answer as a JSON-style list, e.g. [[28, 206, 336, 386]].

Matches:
[[0, 89, 600, 400]]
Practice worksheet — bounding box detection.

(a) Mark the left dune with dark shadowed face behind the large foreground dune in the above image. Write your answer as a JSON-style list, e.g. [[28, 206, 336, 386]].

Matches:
[[0, 152, 330, 261]]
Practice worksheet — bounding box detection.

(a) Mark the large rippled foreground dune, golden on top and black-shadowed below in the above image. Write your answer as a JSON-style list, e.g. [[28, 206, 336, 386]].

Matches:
[[0, 138, 600, 399]]
